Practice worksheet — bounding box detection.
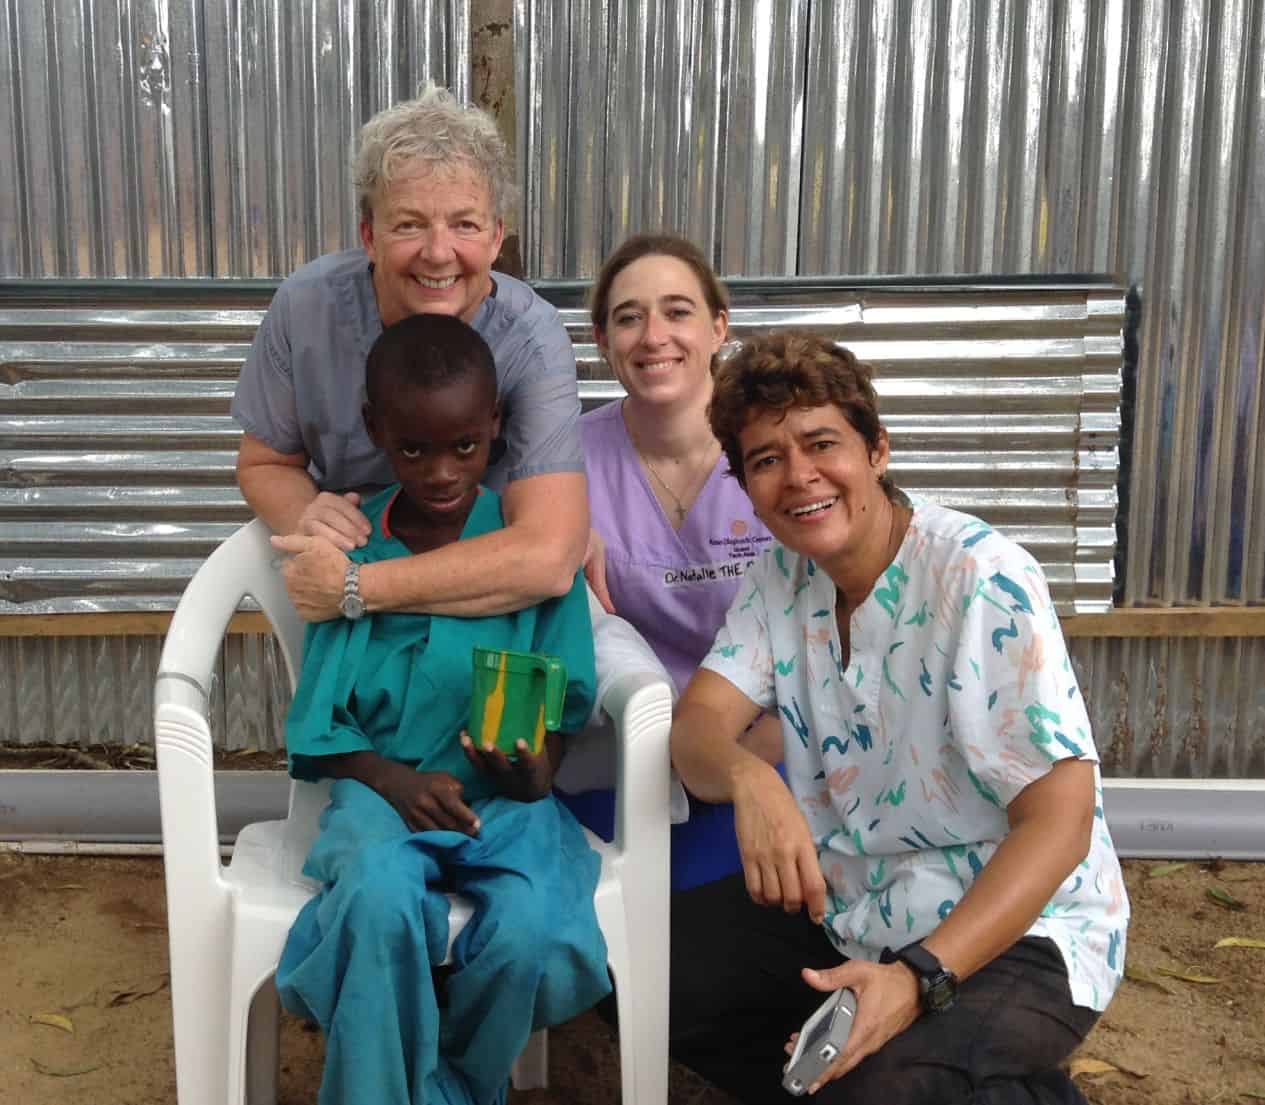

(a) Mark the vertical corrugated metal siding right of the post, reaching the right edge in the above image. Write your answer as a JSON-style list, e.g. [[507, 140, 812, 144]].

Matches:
[[517, 0, 1265, 606]]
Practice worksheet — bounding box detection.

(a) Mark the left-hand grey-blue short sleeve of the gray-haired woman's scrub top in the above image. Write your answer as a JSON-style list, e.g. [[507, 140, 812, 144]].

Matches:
[[231, 283, 305, 454]]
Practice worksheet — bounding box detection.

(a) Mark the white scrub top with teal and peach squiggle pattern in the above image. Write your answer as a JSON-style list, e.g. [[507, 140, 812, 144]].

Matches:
[[702, 502, 1128, 1010]]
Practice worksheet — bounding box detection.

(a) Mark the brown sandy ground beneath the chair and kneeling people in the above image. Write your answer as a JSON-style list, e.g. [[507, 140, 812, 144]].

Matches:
[[0, 853, 1265, 1105]]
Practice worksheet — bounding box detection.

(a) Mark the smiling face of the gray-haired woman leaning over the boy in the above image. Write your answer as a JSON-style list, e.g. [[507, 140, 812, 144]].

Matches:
[[361, 159, 503, 326]]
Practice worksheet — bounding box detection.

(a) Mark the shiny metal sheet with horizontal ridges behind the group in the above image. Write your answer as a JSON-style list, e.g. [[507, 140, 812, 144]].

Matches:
[[0, 281, 1125, 613]]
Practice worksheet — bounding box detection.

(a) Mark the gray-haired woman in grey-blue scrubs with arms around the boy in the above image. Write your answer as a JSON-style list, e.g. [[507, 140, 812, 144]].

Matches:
[[233, 85, 588, 621]]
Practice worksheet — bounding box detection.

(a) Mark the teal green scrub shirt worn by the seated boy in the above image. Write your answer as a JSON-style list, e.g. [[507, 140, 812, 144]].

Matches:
[[286, 484, 597, 802]]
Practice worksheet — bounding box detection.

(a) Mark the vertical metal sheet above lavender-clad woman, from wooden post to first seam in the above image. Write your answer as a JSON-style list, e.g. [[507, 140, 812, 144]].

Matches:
[[515, 0, 810, 277]]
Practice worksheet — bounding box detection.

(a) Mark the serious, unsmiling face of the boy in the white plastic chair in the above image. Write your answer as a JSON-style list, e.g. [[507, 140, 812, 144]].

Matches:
[[364, 373, 501, 544]]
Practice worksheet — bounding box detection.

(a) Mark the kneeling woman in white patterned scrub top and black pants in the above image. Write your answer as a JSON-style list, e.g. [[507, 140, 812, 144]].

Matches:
[[672, 334, 1128, 1105]]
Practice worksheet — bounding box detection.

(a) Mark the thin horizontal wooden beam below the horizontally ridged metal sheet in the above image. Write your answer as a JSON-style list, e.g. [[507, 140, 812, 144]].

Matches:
[[0, 607, 1265, 637]]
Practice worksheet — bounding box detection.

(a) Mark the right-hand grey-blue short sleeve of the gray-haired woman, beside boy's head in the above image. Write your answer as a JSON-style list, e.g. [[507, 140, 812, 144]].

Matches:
[[501, 302, 584, 482]]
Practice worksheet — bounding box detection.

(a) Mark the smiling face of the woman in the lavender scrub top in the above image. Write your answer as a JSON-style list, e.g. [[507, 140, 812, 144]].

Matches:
[[595, 254, 729, 405]]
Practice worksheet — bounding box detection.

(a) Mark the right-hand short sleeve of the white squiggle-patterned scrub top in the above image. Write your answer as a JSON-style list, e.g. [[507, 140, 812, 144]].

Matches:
[[949, 535, 1098, 808]]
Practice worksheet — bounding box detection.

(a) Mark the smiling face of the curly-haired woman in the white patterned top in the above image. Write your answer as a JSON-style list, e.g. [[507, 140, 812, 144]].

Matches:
[[739, 403, 891, 570]]
